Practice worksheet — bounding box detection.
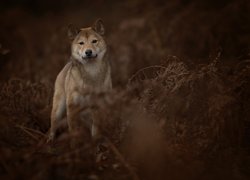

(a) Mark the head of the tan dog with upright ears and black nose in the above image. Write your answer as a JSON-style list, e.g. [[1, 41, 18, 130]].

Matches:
[[68, 19, 107, 64]]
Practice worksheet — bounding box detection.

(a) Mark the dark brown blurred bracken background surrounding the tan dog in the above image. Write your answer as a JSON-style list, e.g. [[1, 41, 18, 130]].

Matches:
[[0, 0, 250, 179]]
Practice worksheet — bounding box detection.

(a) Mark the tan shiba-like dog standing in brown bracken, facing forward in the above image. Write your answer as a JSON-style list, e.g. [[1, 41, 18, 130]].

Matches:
[[48, 19, 112, 141]]
